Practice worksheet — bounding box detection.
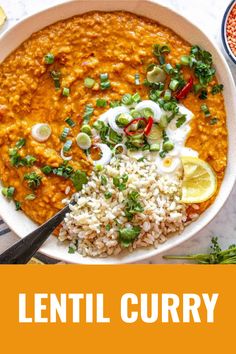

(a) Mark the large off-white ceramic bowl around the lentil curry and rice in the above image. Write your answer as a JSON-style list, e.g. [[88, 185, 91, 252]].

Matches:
[[0, 0, 236, 264]]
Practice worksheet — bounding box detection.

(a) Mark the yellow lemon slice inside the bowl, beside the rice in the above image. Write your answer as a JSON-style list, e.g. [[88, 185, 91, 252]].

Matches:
[[182, 156, 217, 204]]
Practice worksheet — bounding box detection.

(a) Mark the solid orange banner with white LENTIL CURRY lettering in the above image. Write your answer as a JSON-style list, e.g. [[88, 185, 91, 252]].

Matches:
[[0, 265, 236, 354]]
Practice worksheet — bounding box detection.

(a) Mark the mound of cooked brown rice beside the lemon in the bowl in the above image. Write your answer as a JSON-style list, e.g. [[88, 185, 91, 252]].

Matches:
[[59, 155, 187, 257]]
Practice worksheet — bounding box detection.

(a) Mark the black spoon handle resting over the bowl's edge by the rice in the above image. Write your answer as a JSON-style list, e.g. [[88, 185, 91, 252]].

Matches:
[[0, 201, 75, 264]]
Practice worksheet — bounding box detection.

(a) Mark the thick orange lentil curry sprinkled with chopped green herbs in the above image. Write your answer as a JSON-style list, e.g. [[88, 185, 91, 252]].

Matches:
[[0, 12, 227, 223]]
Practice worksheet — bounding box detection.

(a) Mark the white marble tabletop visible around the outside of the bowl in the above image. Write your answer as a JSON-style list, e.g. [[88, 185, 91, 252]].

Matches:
[[0, 0, 236, 263]]
